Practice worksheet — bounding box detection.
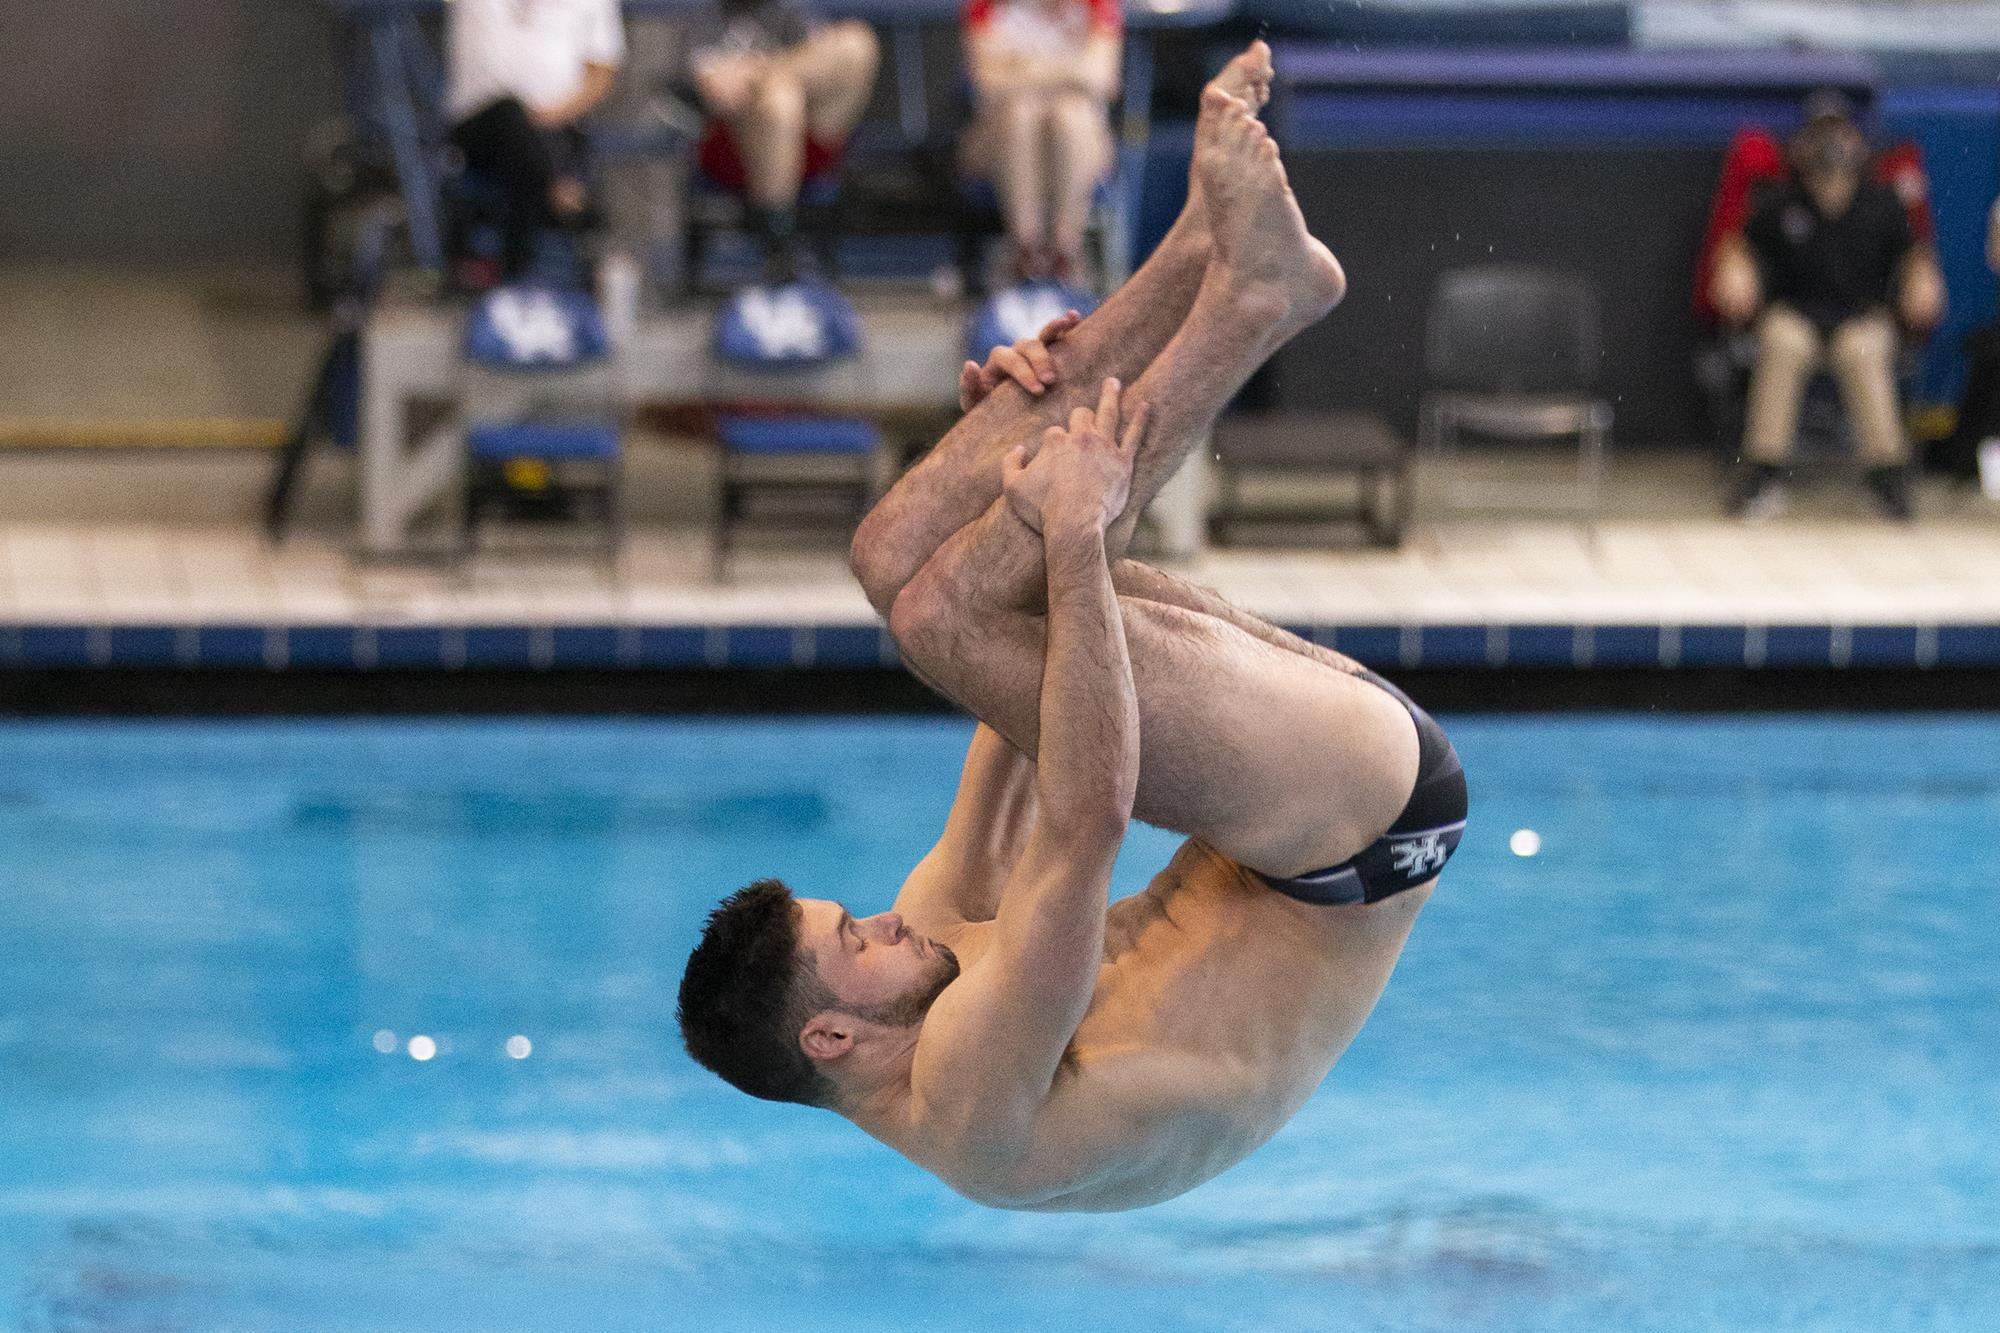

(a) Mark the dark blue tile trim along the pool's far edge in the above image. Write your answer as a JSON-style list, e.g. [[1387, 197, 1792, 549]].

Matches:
[[0, 622, 2000, 671]]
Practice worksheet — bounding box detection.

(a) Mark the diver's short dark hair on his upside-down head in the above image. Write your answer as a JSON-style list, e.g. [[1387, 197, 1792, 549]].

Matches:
[[678, 879, 834, 1107]]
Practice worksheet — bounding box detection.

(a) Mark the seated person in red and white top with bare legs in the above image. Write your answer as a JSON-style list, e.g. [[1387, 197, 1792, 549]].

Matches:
[[964, 0, 1124, 284]]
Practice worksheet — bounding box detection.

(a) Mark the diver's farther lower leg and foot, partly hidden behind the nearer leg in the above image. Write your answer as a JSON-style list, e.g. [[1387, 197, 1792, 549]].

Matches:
[[850, 42, 1280, 614]]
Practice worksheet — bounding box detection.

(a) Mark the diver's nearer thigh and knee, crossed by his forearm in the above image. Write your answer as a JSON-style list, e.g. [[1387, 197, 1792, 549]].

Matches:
[[890, 498, 1416, 875]]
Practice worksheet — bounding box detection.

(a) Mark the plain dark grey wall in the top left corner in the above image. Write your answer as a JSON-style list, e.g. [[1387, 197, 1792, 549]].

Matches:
[[0, 0, 340, 264]]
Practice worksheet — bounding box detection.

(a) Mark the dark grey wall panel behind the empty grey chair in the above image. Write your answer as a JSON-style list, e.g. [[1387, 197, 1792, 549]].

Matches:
[[1258, 148, 1720, 444]]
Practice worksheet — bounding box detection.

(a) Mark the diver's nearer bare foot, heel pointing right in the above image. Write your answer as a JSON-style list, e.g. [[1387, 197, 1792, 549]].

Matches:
[[1194, 84, 1346, 348]]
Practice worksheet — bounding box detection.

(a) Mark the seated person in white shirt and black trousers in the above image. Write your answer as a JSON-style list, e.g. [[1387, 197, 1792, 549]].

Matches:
[[444, 0, 624, 278]]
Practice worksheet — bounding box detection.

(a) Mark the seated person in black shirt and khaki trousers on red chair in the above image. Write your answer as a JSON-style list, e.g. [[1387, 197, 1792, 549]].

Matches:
[[1710, 92, 1944, 518]]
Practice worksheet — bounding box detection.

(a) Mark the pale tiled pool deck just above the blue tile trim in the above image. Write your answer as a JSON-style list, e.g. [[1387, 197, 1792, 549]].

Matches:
[[0, 450, 2000, 624]]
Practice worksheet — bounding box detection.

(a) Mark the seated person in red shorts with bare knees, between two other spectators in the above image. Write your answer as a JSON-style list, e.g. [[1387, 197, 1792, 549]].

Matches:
[[688, 0, 880, 282]]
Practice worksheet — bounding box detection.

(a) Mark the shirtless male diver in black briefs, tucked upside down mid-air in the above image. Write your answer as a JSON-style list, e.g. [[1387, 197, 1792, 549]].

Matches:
[[680, 42, 1466, 1211]]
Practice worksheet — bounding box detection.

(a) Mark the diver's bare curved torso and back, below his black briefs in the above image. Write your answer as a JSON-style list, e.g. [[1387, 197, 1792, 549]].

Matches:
[[888, 839, 1430, 1211]]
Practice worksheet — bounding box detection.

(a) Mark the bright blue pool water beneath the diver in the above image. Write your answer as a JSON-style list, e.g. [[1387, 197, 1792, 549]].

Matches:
[[0, 719, 2000, 1331]]
